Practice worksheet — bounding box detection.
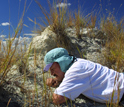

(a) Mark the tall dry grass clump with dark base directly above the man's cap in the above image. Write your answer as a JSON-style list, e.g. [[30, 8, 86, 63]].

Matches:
[[35, 0, 72, 49]]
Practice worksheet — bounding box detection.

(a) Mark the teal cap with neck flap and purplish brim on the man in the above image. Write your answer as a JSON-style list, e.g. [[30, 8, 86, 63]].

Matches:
[[44, 48, 73, 72]]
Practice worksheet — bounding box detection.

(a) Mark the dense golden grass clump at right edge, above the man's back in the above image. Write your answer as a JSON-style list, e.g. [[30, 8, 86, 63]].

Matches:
[[101, 16, 124, 72]]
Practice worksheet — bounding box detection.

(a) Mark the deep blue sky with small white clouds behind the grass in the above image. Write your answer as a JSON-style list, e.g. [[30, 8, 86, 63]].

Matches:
[[0, 0, 124, 49]]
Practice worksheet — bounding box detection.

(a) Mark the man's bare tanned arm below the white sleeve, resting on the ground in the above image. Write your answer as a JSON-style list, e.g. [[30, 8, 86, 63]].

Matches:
[[52, 93, 68, 105]]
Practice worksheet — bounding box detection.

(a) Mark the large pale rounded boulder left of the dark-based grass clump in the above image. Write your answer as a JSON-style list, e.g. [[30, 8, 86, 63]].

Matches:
[[27, 27, 56, 55]]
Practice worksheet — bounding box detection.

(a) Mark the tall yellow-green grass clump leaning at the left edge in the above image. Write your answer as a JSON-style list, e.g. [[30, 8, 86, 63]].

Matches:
[[0, 14, 23, 85]]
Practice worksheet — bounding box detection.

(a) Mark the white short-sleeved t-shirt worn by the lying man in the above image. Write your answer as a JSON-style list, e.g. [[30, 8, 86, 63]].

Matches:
[[54, 58, 124, 103]]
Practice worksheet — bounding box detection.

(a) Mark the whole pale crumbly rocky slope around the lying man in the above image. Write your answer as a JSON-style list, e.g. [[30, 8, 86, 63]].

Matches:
[[0, 27, 106, 107]]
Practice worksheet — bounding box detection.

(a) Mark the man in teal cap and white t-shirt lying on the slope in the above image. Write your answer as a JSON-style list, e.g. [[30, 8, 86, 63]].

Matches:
[[44, 48, 124, 105]]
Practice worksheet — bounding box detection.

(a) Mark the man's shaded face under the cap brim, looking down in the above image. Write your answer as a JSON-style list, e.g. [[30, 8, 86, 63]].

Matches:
[[50, 62, 65, 81]]
